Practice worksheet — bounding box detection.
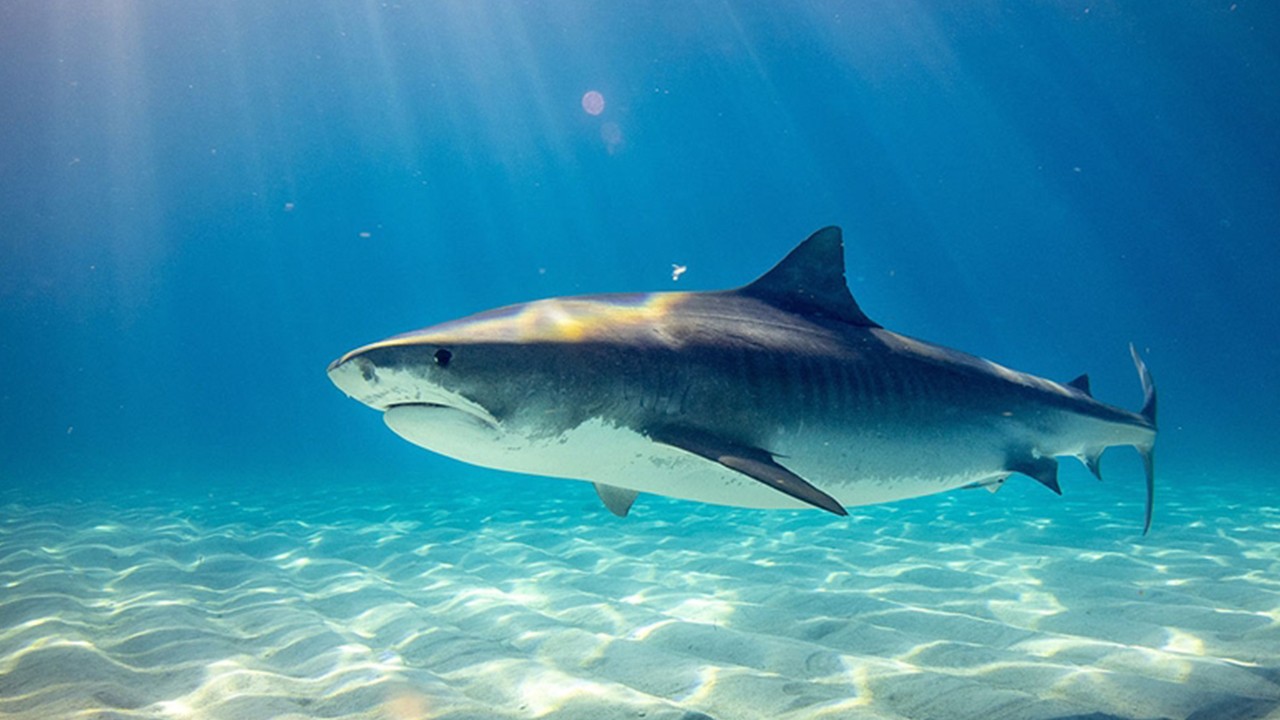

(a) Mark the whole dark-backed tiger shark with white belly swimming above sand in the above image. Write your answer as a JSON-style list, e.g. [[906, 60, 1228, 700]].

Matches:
[[329, 227, 1156, 533]]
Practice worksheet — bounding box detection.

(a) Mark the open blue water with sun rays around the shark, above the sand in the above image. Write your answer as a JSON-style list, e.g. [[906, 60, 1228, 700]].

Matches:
[[0, 0, 1280, 712]]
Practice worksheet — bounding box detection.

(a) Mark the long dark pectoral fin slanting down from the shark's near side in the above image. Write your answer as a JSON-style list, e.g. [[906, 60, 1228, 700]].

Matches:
[[648, 427, 849, 515]]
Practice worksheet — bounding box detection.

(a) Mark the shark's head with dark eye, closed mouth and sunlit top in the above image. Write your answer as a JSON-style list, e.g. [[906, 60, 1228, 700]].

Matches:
[[329, 293, 681, 471]]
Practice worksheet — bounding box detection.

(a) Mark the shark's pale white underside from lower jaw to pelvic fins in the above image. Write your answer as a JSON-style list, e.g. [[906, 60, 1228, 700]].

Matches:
[[384, 406, 1005, 509]]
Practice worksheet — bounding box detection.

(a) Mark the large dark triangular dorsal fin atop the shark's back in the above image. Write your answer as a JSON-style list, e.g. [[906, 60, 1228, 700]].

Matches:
[[736, 225, 879, 328]]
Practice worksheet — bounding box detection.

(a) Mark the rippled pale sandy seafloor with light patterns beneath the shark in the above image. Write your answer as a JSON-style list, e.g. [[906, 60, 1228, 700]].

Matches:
[[0, 473, 1280, 720]]
